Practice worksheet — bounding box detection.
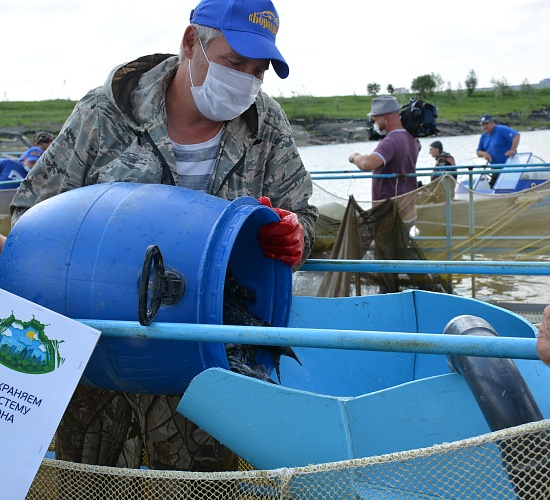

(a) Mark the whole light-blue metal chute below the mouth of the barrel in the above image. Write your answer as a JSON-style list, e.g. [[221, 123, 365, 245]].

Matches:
[[178, 291, 550, 468]]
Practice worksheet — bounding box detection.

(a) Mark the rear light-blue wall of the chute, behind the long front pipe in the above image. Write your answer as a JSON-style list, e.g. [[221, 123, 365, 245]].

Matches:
[[281, 290, 534, 396]]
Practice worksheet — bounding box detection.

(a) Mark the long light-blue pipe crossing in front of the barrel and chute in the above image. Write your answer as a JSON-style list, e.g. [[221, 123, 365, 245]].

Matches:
[[78, 319, 539, 360]]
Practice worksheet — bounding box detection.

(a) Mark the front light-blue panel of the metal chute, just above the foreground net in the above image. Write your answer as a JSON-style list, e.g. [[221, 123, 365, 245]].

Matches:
[[178, 368, 549, 469]]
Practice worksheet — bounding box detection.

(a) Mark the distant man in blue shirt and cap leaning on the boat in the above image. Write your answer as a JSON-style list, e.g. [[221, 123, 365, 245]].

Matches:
[[477, 115, 520, 187]]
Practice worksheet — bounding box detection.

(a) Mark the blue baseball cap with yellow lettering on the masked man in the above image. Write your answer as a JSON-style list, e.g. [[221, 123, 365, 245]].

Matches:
[[189, 0, 289, 78]]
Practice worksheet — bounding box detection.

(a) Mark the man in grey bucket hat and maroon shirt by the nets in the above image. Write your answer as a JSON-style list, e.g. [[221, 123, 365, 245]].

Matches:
[[349, 96, 420, 225]]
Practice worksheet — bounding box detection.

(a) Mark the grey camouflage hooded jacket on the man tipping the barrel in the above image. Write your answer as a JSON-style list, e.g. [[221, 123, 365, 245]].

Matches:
[[10, 54, 318, 260]]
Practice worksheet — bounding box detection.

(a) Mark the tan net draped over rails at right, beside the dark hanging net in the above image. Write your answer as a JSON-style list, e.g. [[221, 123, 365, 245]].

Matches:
[[416, 175, 550, 260]]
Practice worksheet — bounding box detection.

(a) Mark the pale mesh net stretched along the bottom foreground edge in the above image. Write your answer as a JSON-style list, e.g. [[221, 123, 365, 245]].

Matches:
[[26, 420, 550, 500]]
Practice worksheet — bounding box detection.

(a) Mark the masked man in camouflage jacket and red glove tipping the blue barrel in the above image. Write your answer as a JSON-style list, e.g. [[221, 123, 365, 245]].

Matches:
[[11, 0, 318, 471]]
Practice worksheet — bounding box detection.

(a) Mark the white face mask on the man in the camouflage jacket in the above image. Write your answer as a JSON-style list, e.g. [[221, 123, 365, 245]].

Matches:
[[189, 43, 263, 122]]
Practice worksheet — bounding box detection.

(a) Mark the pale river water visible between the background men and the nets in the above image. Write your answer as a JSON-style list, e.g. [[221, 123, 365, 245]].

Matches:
[[298, 130, 550, 312]]
